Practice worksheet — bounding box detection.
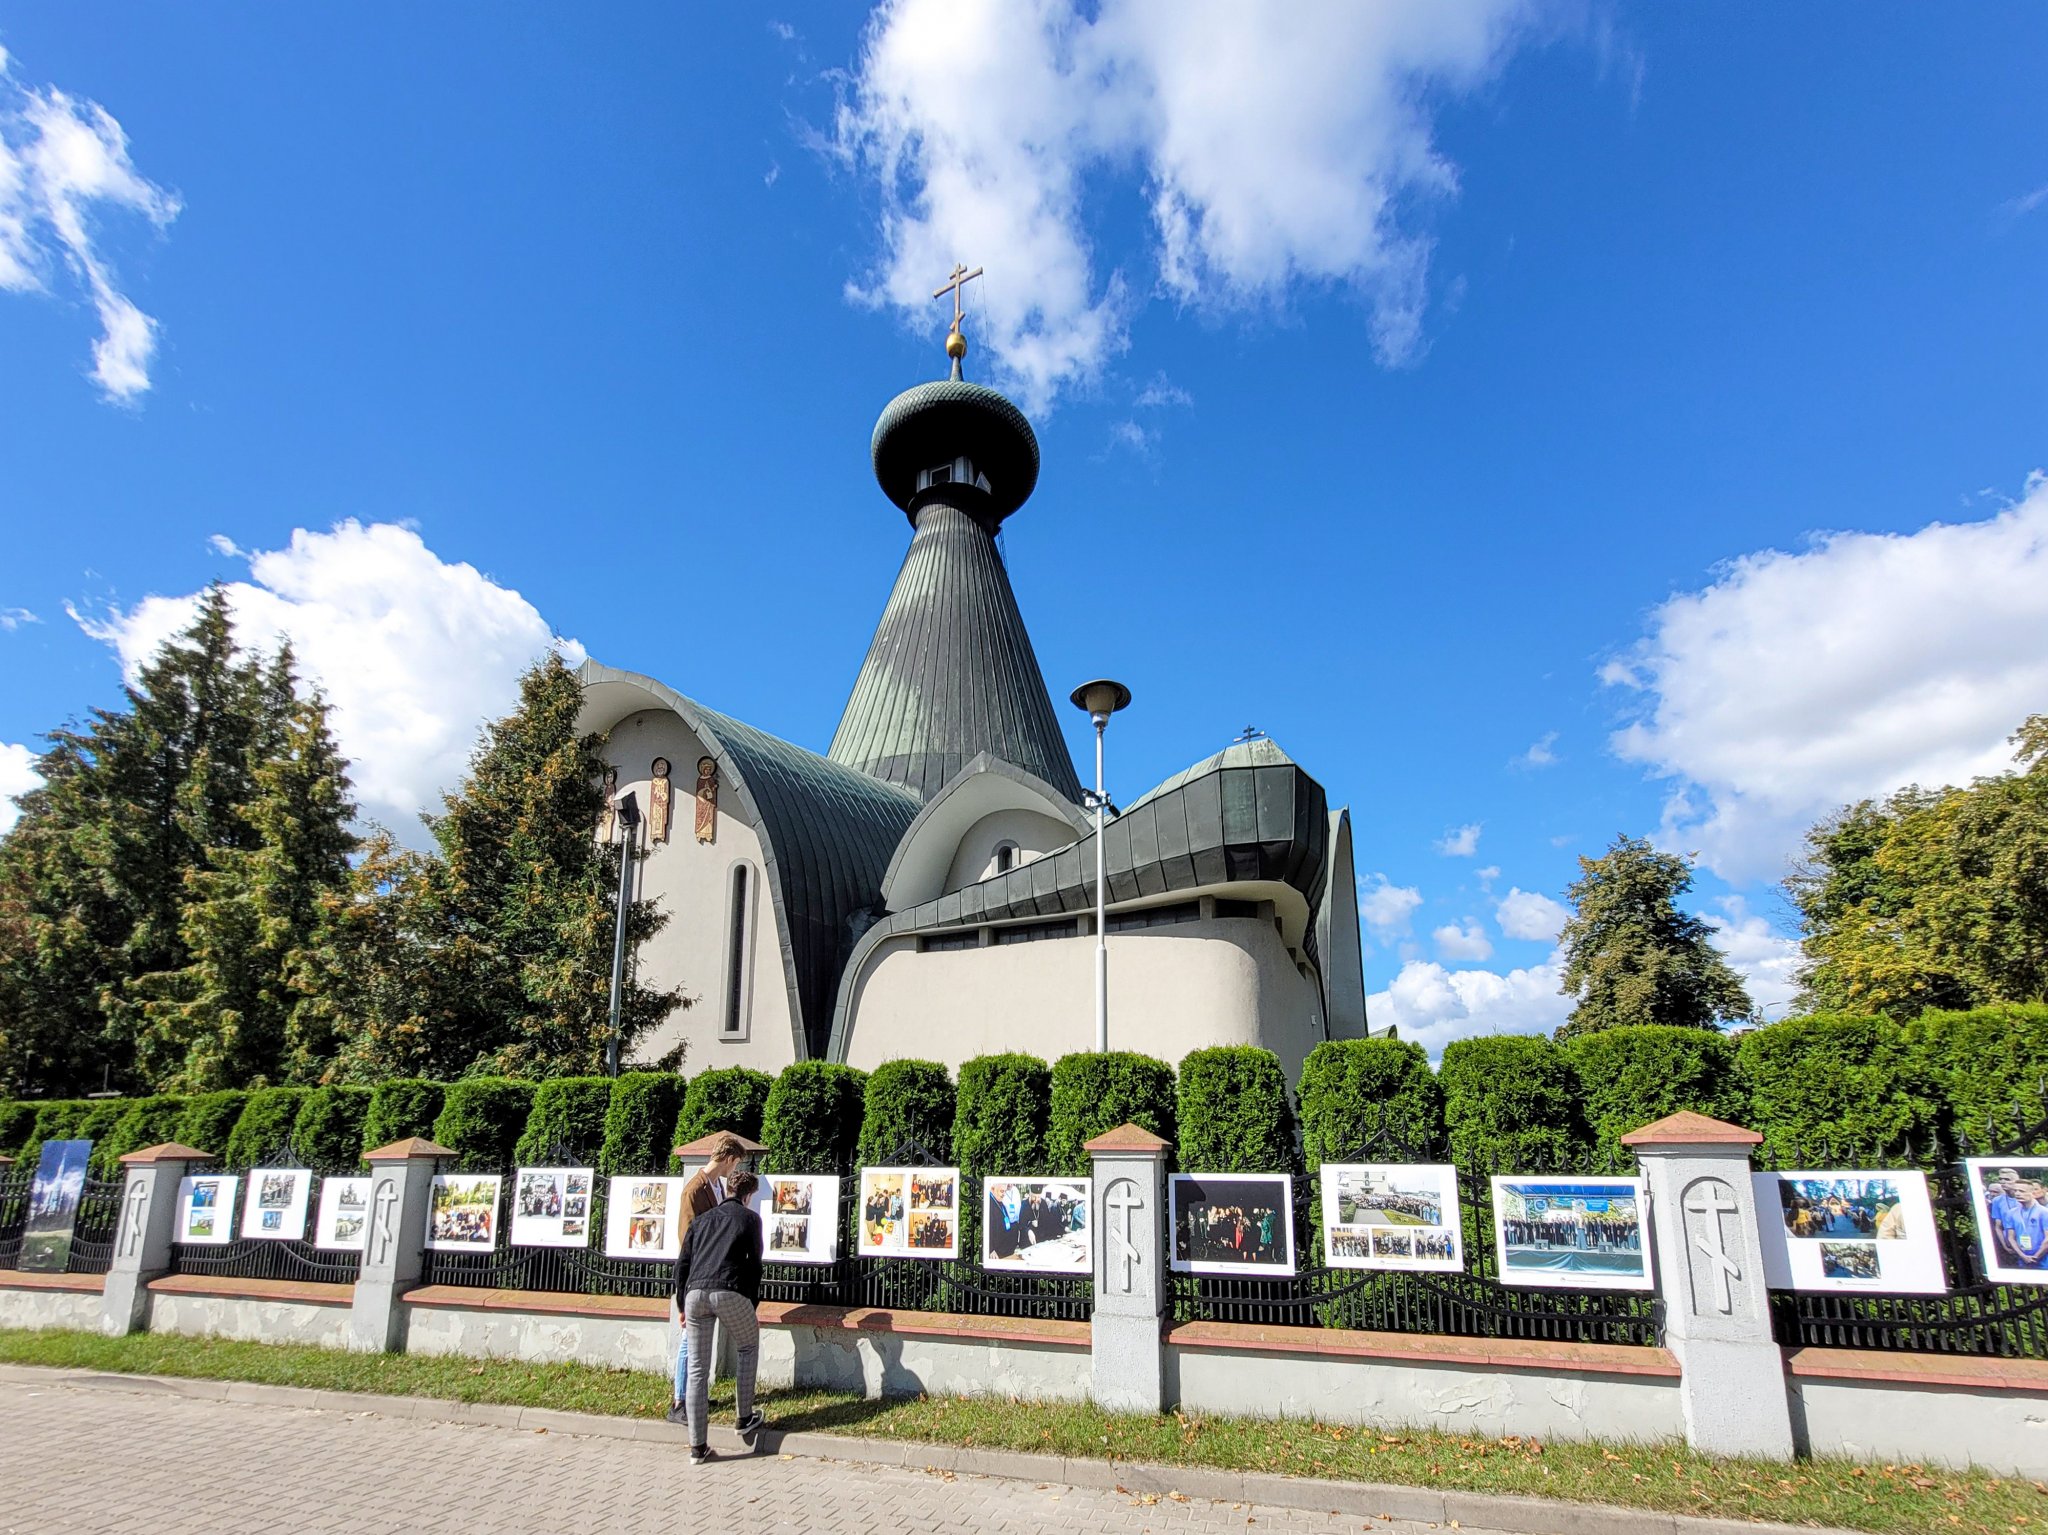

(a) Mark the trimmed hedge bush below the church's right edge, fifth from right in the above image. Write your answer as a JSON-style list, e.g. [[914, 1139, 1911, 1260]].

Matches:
[[1300, 1040, 1444, 1173]]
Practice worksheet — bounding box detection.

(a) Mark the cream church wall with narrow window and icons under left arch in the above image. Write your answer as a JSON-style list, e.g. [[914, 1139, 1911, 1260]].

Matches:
[[604, 708, 797, 1077]]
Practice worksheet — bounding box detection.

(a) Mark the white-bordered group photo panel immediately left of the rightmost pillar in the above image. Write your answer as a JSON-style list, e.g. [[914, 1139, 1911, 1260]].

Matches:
[[1493, 1175, 1655, 1289]]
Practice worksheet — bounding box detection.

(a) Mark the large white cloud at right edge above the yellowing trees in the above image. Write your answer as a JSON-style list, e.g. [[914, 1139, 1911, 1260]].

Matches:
[[1599, 475, 2048, 882]]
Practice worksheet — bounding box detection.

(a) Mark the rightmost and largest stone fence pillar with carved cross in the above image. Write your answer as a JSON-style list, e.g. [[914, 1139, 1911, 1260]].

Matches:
[[1622, 1111, 1792, 1461]]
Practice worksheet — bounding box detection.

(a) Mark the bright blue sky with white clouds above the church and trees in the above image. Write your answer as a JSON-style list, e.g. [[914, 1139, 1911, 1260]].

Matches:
[[0, 0, 2048, 1046]]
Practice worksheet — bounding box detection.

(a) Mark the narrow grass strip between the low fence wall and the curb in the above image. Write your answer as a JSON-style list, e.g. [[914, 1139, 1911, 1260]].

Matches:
[[0, 1328, 2048, 1535]]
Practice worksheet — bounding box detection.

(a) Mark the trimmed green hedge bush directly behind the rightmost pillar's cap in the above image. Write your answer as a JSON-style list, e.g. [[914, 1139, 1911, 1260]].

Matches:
[[1563, 1023, 1749, 1156]]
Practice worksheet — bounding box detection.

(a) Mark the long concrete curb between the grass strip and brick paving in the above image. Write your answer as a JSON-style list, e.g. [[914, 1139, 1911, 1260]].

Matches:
[[0, 1365, 1855, 1535]]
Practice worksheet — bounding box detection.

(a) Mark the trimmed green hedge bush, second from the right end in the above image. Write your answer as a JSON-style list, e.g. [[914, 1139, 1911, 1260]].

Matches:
[[1735, 1013, 1939, 1167]]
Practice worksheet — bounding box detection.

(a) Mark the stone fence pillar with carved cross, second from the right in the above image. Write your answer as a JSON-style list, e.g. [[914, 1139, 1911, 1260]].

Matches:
[[1083, 1124, 1169, 1412]]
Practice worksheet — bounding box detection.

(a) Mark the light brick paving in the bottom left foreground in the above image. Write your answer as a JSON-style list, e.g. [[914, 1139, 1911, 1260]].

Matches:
[[0, 1382, 1515, 1535]]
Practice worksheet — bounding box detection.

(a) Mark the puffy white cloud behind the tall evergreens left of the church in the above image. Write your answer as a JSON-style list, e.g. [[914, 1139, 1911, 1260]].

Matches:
[[72, 520, 584, 841]]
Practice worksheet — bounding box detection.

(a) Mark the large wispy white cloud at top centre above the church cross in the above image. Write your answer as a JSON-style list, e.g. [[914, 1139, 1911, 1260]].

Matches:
[[834, 0, 1530, 407]]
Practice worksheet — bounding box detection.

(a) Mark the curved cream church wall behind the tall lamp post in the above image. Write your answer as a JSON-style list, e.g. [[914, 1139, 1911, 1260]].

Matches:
[[846, 917, 1325, 1079]]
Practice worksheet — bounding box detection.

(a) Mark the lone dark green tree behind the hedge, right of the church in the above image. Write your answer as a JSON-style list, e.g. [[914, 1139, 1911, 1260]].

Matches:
[[1556, 837, 1753, 1040]]
